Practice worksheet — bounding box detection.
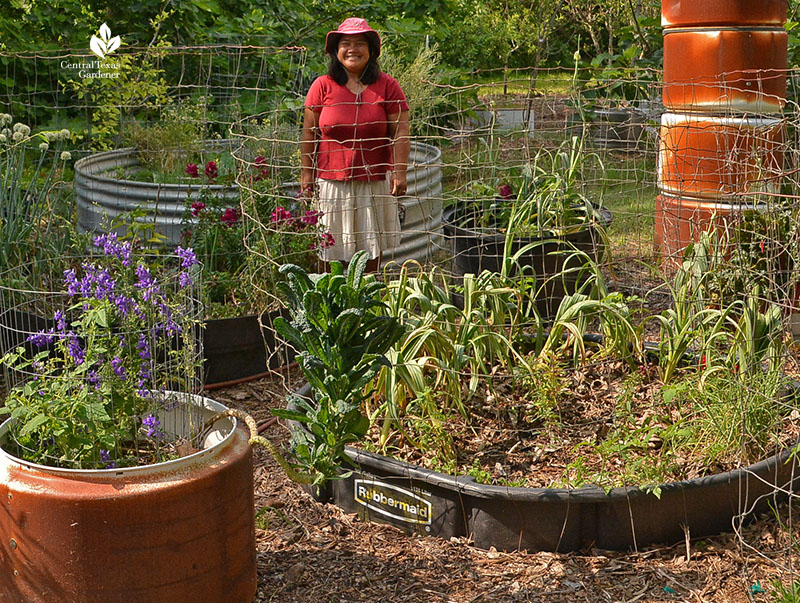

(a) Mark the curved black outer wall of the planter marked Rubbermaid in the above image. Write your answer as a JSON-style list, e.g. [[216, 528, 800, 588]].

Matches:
[[292, 385, 800, 553]]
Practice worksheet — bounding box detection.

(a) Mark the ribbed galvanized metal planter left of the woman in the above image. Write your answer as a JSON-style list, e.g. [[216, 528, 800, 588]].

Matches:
[[75, 141, 239, 246]]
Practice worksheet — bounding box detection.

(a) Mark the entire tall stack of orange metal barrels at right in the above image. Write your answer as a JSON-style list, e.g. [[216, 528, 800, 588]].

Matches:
[[655, 0, 788, 266]]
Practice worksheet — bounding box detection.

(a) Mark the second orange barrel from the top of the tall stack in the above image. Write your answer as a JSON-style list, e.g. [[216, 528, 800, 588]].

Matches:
[[662, 28, 788, 113]]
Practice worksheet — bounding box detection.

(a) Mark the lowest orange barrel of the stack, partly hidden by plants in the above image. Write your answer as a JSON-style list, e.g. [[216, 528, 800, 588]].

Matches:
[[655, 194, 766, 269]]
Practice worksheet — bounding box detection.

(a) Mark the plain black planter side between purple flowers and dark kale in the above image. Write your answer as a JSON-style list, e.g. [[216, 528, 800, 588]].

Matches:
[[203, 309, 294, 385]]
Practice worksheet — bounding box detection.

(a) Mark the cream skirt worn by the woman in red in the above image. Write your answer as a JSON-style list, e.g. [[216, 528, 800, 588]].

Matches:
[[317, 179, 400, 262]]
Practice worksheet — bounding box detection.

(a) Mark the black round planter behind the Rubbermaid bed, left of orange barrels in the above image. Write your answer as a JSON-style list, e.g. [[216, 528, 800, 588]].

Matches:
[[442, 207, 611, 316]]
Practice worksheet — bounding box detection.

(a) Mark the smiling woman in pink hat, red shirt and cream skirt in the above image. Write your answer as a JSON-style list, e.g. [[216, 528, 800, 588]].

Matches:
[[300, 17, 410, 272]]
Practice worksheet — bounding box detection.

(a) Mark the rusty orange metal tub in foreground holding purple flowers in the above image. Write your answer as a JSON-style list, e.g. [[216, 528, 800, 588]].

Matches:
[[0, 396, 256, 603]]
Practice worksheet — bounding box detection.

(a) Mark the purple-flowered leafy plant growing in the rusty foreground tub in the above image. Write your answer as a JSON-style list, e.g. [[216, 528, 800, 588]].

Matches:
[[0, 234, 200, 469]]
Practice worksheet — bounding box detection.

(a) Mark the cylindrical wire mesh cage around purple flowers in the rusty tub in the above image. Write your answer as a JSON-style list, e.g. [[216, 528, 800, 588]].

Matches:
[[0, 251, 205, 469]]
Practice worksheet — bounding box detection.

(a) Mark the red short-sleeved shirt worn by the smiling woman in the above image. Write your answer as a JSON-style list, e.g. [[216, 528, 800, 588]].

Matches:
[[305, 73, 408, 180]]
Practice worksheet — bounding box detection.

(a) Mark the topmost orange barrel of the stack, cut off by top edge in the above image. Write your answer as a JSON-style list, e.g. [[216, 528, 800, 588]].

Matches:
[[661, 0, 787, 27]]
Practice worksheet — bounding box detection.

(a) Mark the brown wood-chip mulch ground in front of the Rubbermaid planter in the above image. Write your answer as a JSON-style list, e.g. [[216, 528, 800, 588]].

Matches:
[[214, 376, 800, 603]]
